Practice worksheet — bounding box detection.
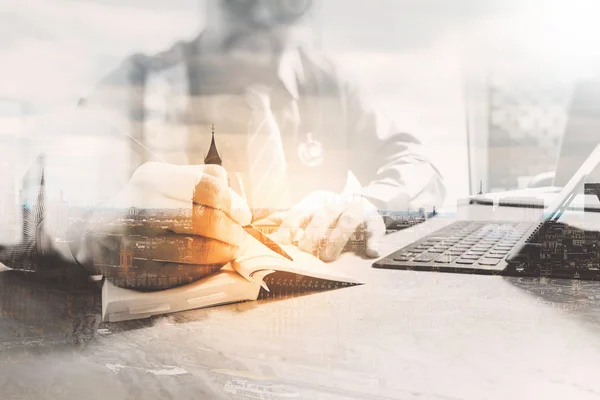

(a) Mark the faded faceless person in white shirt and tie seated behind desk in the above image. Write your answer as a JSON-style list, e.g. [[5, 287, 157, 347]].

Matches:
[[0, 0, 445, 288]]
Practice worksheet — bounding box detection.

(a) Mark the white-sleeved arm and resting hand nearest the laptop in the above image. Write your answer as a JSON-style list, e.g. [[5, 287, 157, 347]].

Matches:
[[271, 57, 445, 261]]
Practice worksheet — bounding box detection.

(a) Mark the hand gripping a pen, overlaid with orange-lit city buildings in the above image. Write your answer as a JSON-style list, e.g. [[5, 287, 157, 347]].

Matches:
[[71, 162, 290, 289]]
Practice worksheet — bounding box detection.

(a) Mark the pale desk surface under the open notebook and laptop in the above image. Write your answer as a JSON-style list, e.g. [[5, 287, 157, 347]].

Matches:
[[0, 208, 600, 400]]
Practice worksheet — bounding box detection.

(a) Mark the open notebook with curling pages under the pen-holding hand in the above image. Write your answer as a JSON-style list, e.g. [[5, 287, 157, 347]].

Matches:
[[102, 236, 362, 322]]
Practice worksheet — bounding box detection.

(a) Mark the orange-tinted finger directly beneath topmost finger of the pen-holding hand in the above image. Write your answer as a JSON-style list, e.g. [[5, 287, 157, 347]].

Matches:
[[192, 204, 247, 246]]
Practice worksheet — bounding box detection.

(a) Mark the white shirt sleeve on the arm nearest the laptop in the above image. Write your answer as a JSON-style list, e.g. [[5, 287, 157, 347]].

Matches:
[[344, 78, 446, 210]]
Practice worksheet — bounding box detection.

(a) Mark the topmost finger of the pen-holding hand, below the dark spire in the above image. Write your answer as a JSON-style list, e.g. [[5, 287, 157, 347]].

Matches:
[[192, 174, 252, 225]]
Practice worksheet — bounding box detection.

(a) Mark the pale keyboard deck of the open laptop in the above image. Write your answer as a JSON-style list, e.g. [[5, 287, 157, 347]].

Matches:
[[373, 221, 531, 272]]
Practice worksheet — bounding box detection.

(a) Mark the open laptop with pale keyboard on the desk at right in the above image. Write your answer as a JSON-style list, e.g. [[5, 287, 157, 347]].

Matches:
[[373, 145, 600, 280]]
